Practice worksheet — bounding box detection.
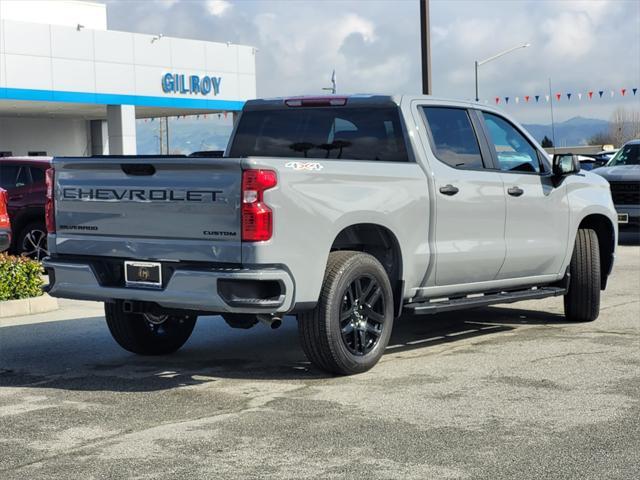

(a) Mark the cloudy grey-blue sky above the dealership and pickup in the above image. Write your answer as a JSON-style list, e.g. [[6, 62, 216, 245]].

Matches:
[[103, 0, 640, 124]]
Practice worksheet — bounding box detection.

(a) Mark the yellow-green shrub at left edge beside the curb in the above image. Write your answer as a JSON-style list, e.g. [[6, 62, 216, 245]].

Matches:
[[0, 254, 43, 301]]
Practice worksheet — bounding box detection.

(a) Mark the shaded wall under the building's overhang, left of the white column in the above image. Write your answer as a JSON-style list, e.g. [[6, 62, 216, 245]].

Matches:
[[0, 117, 91, 156]]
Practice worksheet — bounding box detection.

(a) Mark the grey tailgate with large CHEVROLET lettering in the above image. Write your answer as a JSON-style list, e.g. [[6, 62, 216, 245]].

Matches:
[[51, 157, 242, 263]]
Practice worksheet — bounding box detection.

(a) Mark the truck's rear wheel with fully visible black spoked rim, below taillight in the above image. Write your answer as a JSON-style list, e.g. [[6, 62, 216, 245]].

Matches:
[[298, 251, 394, 375]]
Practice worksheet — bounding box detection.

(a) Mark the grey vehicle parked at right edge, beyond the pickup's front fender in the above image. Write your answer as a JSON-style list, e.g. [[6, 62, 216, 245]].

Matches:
[[593, 140, 640, 230]]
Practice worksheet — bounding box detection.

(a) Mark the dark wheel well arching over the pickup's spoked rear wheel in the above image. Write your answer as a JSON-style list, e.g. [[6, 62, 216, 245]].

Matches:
[[331, 223, 404, 314]]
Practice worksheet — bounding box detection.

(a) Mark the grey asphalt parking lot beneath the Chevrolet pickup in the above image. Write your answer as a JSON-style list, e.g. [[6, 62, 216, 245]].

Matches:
[[0, 246, 640, 480]]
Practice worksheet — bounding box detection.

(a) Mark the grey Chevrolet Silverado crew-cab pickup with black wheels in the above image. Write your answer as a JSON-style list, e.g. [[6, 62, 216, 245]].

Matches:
[[44, 95, 618, 374]]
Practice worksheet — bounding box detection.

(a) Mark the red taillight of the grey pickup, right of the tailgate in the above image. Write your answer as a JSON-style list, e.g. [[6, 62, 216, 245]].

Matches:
[[242, 170, 278, 242]]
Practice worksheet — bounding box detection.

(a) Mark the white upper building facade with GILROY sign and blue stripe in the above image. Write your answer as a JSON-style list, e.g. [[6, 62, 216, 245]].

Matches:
[[0, 18, 256, 106]]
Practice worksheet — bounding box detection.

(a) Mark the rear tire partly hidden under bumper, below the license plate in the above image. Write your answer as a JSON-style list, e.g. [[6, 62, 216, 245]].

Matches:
[[104, 301, 198, 355]]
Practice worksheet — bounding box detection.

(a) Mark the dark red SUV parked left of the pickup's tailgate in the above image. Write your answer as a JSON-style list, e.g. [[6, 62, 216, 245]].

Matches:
[[0, 157, 51, 260]]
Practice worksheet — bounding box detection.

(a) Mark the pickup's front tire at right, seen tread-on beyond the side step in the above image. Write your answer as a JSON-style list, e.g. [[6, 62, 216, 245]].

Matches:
[[564, 228, 601, 322]]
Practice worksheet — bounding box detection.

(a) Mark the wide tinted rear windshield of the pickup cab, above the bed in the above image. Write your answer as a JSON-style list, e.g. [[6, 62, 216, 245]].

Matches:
[[229, 107, 409, 162]]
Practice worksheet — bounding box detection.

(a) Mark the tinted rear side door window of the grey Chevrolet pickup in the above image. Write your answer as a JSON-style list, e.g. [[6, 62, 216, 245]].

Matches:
[[423, 107, 484, 170]]
